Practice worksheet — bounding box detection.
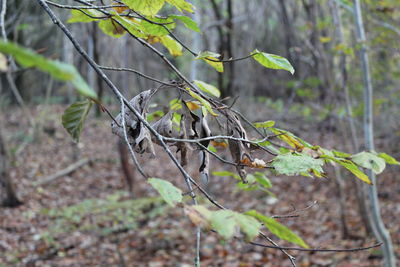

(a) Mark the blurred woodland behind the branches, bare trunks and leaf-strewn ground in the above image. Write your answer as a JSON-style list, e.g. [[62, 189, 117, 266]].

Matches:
[[0, 0, 400, 266]]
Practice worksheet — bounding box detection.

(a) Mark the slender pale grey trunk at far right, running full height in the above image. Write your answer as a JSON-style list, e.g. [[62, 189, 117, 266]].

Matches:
[[354, 0, 396, 267]]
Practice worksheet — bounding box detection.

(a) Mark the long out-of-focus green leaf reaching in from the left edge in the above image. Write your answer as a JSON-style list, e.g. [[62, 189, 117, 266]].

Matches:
[[0, 41, 97, 99]]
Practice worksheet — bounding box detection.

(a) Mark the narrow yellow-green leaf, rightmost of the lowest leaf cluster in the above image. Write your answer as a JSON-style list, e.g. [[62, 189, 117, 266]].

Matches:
[[245, 210, 308, 248]]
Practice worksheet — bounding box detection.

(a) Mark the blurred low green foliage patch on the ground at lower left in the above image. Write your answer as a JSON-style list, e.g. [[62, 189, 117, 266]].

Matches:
[[40, 192, 167, 241]]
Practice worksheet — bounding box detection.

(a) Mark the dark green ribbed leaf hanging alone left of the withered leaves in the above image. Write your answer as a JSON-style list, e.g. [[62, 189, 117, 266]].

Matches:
[[62, 99, 92, 142]]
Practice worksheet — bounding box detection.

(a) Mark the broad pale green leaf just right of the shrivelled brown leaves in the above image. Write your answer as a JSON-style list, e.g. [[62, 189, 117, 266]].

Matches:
[[272, 153, 324, 176]]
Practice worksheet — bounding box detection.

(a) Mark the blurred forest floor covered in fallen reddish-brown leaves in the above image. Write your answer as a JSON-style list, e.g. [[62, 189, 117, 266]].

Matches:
[[0, 106, 400, 267]]
